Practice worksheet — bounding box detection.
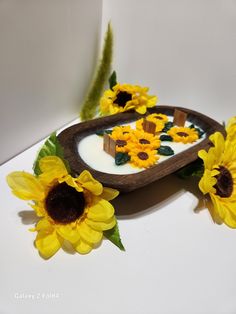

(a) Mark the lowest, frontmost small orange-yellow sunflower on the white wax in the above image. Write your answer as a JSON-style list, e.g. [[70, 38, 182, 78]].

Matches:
[[129, 147, 159, 168]]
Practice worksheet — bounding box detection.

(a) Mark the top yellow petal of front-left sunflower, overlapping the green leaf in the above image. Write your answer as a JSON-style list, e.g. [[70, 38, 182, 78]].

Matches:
[[39, 156, 68, 184]]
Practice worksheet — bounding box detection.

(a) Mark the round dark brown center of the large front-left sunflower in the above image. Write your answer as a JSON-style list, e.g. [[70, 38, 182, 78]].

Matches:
[[46, 182, 85, 224]]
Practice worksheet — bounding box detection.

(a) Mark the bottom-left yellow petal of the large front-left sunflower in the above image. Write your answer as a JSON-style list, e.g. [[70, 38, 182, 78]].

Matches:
[[35, 232, 61, 259]]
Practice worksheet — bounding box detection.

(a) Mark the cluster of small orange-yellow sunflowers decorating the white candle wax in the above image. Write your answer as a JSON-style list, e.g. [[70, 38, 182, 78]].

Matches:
[[105, 113, 203, 168]]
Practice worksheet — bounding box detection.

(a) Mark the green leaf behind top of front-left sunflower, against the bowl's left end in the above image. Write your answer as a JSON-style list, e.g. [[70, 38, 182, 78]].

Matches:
[[33, 132, 70, 176]]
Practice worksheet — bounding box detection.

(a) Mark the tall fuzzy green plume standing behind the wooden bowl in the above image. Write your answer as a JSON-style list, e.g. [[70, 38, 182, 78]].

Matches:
[[80, 23, 113, 120]]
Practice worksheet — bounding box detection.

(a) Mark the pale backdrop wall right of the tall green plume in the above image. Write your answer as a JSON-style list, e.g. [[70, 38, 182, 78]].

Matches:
[[103, 0, 236, 122]]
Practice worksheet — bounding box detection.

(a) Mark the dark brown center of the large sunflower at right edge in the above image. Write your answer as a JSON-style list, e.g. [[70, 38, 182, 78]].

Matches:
[[214, 166, 233, 197]]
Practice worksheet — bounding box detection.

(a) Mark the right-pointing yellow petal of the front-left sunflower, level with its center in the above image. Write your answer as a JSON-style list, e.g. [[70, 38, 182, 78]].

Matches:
[[87, 199, 114, 221]]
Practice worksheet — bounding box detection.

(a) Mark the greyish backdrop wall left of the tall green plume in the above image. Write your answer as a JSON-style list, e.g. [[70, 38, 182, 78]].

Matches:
[[0, 0, 102, 163]]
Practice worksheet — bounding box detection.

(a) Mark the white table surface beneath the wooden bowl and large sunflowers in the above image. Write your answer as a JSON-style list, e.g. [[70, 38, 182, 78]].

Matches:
[[0, 116, 236, 314]]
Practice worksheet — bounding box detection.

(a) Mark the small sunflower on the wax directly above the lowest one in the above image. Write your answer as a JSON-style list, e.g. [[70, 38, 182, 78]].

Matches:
[[131, 130, 161, 150]]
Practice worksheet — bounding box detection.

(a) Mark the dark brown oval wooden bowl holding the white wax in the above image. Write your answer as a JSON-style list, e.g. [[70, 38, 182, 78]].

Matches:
[[58, 106, 225, 192]]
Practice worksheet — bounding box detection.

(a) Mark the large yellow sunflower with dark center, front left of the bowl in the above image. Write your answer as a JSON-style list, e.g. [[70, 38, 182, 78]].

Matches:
[[7, 156, 118, 259]]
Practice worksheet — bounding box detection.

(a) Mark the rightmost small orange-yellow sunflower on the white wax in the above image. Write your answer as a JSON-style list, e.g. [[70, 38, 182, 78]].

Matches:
[[167, 126, 199, 144]]
